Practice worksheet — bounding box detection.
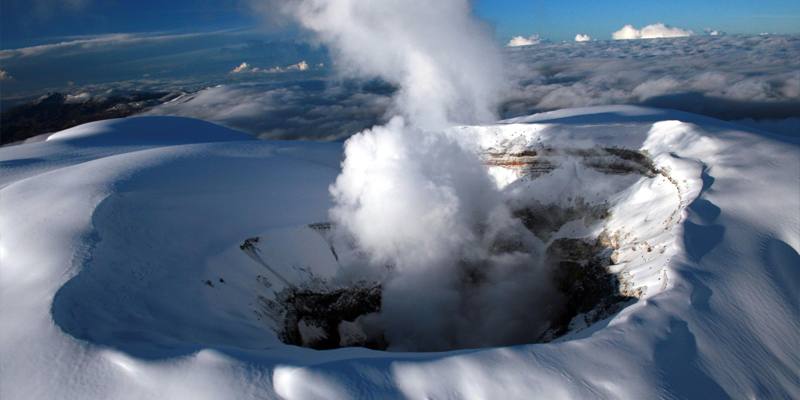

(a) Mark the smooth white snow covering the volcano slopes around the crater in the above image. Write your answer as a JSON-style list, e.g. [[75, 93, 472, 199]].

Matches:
[[0, 106, 800, 399]]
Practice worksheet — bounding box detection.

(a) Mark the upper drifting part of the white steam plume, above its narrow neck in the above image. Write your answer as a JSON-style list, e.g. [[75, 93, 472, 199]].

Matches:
[[284, 0, 503, 129]]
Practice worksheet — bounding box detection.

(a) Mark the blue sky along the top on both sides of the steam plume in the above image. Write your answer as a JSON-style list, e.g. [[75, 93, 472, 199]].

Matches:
[[0, 0, 800, 49]]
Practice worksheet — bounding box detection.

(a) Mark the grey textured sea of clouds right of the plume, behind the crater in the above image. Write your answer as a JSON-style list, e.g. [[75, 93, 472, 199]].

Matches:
[[504, 35, 800, 119]]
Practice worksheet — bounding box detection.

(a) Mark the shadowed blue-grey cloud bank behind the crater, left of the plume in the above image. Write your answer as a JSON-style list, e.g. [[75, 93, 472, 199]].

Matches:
[[148, 80, 393, 140]]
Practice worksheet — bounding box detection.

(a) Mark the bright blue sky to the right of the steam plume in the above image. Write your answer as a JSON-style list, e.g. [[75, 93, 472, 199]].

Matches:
[[476, 0, 800, 40]]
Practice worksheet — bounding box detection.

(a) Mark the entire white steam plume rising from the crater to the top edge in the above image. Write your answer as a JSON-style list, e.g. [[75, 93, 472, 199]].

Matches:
[[276, 0, 552, 350]]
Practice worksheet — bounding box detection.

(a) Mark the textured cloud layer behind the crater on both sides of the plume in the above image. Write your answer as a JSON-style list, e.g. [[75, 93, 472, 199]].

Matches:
[[141, 35, 800, 140]]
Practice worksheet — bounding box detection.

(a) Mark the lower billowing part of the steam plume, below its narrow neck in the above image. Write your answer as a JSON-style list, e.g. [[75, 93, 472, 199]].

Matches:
[[331, 117, 558, 350]]
